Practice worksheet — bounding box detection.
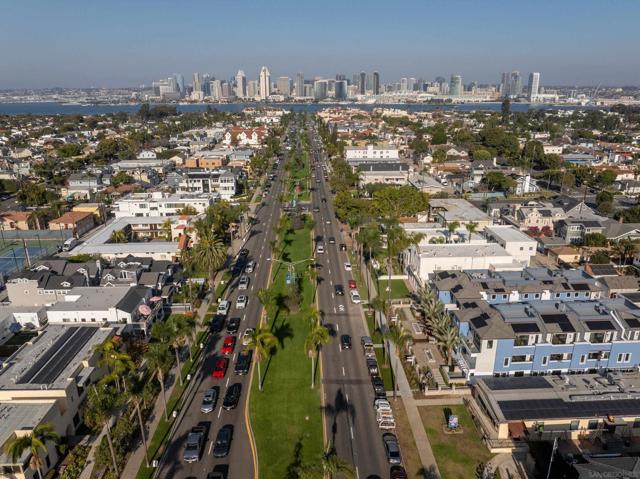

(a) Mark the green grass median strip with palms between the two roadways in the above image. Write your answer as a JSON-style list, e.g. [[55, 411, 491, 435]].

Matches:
[[250, 228, 323, 479]]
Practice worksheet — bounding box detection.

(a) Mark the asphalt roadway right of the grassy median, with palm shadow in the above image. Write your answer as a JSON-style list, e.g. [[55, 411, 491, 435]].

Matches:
[[312, 128, 389, 479]]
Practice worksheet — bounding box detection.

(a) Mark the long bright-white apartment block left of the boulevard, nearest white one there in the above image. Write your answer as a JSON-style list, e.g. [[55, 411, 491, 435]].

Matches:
[[114, 191, 215, 218]]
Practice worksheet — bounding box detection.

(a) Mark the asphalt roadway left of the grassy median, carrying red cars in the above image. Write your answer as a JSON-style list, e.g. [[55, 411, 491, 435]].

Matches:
[[157, 141, 286, 479]]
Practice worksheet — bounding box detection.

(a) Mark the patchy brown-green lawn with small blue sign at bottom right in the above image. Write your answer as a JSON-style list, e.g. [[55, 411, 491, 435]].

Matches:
[[418, 404, 492, 479]]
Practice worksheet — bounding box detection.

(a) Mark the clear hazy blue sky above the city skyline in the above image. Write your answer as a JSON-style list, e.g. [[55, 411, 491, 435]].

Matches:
[[0, 0, 640, 89]]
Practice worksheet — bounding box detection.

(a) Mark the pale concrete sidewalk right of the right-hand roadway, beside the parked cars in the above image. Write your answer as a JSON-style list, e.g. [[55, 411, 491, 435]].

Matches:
[[360, 248, 440, 479]]
